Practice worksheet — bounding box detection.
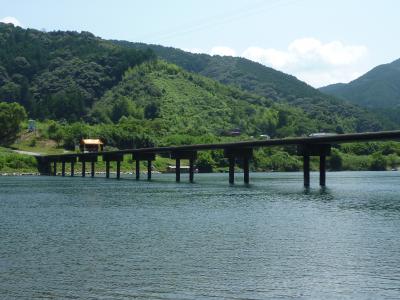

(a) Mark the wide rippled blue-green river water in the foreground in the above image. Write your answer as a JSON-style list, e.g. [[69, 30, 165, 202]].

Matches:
[[0, 172, 400, 299]]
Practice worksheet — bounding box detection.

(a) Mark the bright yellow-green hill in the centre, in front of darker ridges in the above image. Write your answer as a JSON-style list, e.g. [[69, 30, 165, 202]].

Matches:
[[91, 61, 379, 137]]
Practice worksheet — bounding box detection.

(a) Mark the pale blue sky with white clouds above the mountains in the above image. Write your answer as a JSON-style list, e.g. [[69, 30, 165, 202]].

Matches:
[[0, 0, 400, 87]]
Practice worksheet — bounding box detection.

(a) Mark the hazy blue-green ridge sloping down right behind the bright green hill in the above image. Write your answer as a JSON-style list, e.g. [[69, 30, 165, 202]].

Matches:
[[114, 41, 384, 133]]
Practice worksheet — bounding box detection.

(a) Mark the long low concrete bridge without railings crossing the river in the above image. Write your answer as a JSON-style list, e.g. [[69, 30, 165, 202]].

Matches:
[[36, 130, 400, 187]]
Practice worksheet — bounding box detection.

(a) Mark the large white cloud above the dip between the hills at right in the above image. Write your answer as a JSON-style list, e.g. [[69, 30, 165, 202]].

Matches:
[[242, 38, 368, 87]]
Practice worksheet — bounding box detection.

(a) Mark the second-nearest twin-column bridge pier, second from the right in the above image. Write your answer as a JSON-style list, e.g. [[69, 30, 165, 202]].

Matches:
[[224, 148, 253, 184]]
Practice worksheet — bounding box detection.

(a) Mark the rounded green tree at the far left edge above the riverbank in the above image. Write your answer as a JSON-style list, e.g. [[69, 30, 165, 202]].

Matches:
[[0, 102, 26, 146]]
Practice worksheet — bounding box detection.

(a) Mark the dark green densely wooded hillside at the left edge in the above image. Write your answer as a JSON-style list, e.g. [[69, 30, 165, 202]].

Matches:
[[0, 23, 154, 121]]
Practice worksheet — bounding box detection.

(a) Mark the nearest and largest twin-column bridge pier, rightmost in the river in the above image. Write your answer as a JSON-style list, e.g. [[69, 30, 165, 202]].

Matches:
[[297, 144, 331, 187]]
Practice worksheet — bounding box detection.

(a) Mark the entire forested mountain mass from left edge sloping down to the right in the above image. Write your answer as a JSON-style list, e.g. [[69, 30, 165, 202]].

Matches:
[[0, 23, 382, 136]]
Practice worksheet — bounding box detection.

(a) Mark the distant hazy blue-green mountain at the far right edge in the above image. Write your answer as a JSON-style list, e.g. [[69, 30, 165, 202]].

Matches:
[[320, 59, 400, 109]]
